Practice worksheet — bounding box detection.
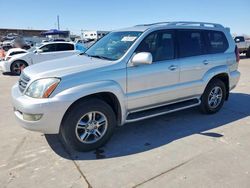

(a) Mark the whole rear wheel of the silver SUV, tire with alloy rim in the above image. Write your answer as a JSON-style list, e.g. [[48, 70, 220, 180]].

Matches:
[[200, 79, 226, 114]]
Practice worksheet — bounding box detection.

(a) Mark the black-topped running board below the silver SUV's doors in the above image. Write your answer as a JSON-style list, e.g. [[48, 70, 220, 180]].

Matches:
[[126, 99, 201, 123]]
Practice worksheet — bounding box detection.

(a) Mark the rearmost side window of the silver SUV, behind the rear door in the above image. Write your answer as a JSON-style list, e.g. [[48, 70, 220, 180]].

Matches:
[[206, 31, 228, 54]]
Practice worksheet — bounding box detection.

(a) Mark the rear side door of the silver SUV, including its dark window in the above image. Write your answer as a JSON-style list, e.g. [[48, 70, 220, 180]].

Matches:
[[177, 29, 210, 98]]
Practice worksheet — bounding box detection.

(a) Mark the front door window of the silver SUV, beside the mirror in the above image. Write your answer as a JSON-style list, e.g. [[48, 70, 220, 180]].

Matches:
[[136, 31, 175, 62]]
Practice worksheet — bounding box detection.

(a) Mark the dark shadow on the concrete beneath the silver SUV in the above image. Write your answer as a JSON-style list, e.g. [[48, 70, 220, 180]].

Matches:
[[45, 93, 250, 160]]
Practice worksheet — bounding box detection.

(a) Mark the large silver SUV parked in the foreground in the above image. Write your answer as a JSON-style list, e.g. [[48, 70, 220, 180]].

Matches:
[[12, 22, 240, 151]]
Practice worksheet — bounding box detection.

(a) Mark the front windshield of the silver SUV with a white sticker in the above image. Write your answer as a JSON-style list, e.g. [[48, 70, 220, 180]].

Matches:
[[84, 31, 142, 60]]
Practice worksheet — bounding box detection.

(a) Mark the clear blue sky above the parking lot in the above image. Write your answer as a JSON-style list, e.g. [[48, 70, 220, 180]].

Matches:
[[0, 0, 250, 35]]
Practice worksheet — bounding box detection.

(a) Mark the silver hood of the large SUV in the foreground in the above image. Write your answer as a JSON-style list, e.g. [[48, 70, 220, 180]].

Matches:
[[23, 55, 112, 78]]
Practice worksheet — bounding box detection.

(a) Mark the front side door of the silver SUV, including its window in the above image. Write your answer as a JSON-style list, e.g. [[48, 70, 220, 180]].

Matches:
[[127, 30, 180, 111]]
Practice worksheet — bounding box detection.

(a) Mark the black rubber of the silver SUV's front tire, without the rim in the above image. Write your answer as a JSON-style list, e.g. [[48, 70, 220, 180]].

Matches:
[[60, 99, 116, 151]]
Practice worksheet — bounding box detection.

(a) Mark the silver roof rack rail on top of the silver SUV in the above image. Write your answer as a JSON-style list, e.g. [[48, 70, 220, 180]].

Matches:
[[136, 21, 224, 28]]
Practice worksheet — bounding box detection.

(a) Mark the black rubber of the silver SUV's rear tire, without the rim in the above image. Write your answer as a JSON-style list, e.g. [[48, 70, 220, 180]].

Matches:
[[200, 79, 226, 114]]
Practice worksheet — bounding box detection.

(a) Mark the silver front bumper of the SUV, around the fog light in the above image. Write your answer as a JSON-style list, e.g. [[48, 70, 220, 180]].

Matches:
[[12, 84, 71, 134]]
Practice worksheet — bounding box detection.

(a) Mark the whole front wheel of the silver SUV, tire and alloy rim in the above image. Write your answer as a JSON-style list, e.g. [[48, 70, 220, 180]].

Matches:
[[59, 98, 116, 152]]
